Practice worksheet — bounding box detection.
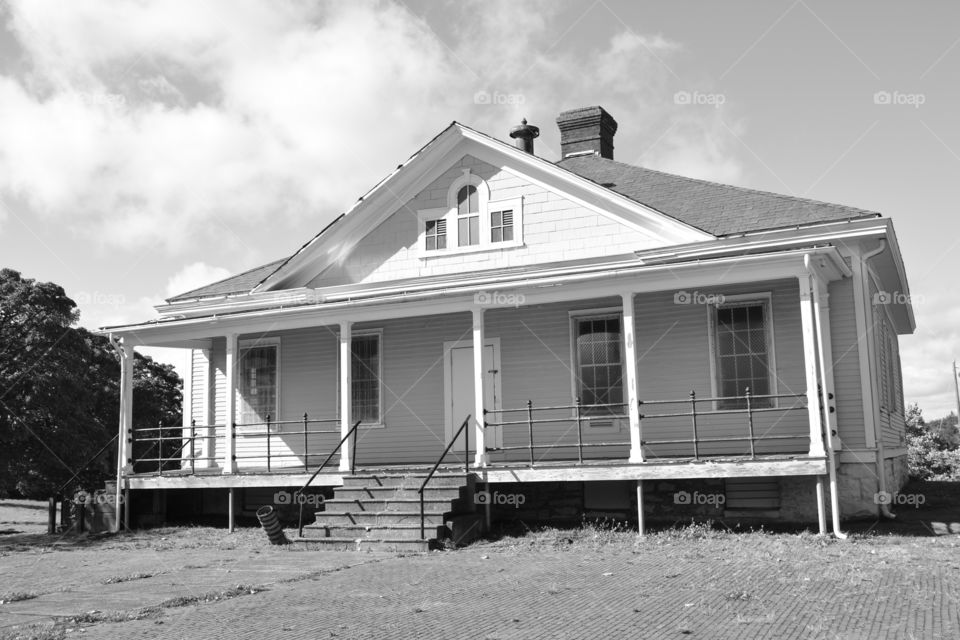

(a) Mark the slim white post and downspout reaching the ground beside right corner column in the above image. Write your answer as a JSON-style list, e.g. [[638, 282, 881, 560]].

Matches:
[[811, 275, 847, 539]]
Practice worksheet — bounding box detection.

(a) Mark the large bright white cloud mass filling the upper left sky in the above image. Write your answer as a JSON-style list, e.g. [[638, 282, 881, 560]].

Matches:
[[0, 0, 739, 255]]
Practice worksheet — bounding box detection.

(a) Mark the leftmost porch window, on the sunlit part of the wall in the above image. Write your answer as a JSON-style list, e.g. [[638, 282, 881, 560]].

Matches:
[[239, 340, 280, 425]]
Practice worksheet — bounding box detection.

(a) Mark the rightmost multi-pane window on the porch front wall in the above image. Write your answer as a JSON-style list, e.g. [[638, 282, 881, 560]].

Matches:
[[713, 300, 773, 409]]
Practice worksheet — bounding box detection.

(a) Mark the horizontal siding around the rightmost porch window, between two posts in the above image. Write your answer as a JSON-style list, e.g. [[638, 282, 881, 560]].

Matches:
[[635, 280, 809, 458]]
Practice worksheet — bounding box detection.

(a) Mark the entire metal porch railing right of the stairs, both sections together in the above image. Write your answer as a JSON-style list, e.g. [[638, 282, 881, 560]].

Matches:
[[484, 388, 809, 466]]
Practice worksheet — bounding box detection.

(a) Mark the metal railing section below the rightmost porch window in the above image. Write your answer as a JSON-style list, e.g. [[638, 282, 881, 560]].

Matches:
[[640, 387, 809, 460]]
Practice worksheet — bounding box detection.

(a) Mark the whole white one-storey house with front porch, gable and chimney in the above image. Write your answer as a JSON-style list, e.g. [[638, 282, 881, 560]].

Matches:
[[103, 107, 914, 542]]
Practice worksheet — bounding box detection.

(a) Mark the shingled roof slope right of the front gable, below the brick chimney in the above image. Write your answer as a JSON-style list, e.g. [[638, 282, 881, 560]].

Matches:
[[557, 155, 880, 237]]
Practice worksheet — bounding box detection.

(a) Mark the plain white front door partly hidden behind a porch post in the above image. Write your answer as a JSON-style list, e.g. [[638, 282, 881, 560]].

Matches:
[[444, 342, 500, 452]]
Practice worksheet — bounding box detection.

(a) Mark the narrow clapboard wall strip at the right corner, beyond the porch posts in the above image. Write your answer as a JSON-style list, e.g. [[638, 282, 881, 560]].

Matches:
[[829, 278, 866, 447]]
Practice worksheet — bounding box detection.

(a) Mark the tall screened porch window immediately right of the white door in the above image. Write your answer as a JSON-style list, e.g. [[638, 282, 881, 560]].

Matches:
[[573, 314, 623, 415]]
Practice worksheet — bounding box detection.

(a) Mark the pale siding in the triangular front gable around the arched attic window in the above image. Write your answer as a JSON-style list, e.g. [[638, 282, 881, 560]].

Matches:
[[307, 155, 663, 287]]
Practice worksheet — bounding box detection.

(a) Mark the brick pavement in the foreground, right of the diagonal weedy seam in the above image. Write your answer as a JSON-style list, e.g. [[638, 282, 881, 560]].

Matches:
[[3, 536, 960, 640]]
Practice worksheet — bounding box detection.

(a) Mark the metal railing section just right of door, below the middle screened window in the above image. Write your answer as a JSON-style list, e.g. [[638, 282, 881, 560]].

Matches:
[[483, 398, 630, 467]]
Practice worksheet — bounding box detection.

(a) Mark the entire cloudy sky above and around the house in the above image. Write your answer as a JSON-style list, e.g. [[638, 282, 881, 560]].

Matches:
[[0, 0, 960, 418]]
